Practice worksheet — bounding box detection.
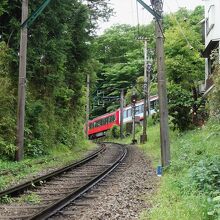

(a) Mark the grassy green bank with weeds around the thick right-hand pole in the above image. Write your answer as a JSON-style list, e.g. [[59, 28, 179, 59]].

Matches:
[[140, 122, 220, 220]]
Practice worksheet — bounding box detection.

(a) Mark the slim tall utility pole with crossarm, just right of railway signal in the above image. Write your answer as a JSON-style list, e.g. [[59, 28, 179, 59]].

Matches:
[[141, 39, 148, 144]]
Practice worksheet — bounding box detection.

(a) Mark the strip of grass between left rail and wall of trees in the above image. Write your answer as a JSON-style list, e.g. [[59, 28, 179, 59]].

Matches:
[[0, 142, 96, 192]]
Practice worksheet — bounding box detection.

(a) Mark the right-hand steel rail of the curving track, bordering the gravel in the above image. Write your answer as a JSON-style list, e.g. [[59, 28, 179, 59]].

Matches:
[[29, 144, 127, 220]]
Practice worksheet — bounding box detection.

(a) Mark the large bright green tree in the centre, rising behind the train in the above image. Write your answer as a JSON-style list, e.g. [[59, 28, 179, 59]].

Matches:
[[93, 24, 154, 115]]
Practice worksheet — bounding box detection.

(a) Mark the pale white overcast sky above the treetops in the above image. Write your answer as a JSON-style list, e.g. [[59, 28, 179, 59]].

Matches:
[[98, 0, 203, 34]]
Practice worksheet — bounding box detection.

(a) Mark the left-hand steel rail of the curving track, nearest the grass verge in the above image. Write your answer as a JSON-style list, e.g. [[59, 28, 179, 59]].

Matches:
[[0, 144, 106, 198]]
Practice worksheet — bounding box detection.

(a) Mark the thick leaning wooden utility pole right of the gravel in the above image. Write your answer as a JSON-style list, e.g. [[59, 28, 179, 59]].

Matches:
[[151, 0, 170, 167]]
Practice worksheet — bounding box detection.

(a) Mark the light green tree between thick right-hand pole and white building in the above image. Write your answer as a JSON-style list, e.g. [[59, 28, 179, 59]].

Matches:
[[165, 7, 204, 130]]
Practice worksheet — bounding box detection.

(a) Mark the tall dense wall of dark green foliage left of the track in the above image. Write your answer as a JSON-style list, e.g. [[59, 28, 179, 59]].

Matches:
[[0, 0, 112, 158]]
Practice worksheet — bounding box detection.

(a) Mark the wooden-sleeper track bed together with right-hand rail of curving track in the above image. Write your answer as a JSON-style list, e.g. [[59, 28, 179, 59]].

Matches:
[[0, 143, 127, 220]]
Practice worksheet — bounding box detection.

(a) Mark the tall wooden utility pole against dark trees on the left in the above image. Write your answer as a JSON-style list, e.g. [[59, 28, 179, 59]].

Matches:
[[15, 0, 28, 161]]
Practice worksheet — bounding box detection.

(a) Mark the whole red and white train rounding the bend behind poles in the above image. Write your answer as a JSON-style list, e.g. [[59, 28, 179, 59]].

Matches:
[[88, 95, 158, 139]]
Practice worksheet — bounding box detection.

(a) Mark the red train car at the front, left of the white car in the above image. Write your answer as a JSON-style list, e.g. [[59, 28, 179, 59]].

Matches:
[[88, 110, 120, 139]]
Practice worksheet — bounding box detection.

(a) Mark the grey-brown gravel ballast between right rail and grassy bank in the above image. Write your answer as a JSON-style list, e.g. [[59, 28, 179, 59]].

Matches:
[[52, 146, 159, 220]]
